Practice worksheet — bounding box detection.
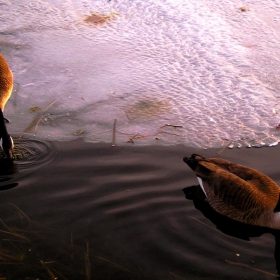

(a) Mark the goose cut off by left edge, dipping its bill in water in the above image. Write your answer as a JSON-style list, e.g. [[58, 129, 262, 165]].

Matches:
[[0, 54, 14, 160]]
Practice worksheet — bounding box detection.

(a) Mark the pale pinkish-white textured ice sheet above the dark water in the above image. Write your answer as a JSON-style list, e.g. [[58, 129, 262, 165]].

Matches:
[[0, 0, 280, 147]]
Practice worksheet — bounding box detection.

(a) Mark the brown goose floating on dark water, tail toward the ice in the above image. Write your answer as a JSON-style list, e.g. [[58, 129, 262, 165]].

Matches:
[[183, 154, 280, 229]]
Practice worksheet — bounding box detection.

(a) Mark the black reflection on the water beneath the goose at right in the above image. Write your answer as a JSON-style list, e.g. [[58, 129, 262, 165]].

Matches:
[[183, 185, 280, 279]]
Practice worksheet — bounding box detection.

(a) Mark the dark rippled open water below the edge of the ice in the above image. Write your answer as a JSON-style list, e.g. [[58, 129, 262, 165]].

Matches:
[[0, 140, 280, 280]]
